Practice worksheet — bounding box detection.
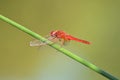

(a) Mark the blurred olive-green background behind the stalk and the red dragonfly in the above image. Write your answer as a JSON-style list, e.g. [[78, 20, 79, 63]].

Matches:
[[0, 0, 120, 80]]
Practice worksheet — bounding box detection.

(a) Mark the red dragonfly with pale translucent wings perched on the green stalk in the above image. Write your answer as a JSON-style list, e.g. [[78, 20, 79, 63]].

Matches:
[[30, 30, 91, 46]]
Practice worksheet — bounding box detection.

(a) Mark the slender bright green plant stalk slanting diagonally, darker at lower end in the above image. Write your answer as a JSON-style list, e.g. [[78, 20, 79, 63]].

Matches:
[[0, 15, 118, 80]]
